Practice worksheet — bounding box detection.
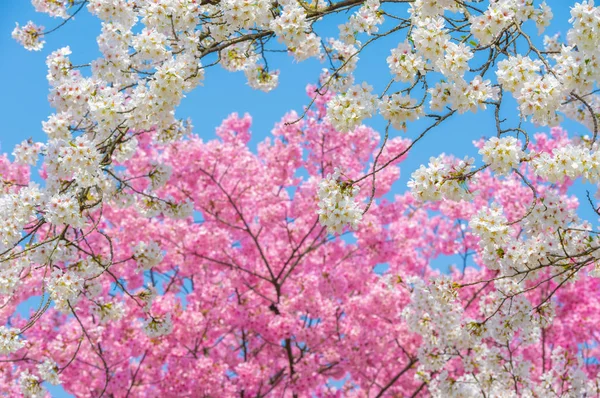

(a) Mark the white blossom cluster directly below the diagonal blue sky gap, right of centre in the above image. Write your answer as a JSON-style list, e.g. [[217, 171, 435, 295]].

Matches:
[[408, 155, 475, 201]]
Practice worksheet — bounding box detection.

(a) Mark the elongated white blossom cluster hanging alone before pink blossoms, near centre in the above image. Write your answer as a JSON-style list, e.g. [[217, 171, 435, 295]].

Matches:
[[317, 168, 362, 234]]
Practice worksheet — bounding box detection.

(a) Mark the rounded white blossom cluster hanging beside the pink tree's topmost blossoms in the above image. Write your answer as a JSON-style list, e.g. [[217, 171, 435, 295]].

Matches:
[[327, 83, 379, 132]]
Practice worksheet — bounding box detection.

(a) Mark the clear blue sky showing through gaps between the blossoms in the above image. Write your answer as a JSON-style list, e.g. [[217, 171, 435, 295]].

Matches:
[[0, 0, 595, 397]]
